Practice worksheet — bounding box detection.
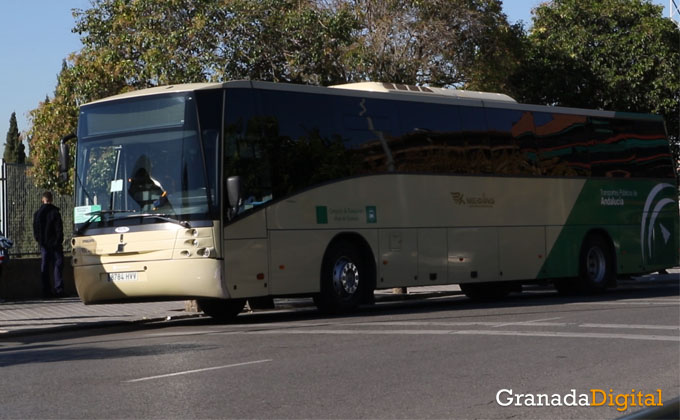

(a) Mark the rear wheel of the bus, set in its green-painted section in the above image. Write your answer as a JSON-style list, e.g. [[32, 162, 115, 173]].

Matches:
[[579, 234, 616, 293]]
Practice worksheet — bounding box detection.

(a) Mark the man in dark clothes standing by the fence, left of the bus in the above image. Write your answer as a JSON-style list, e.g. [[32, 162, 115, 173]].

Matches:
[[33, 191, 64, 297]]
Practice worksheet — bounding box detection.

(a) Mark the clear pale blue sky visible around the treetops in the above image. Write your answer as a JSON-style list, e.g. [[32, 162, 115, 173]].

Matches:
[[0, 0, 669, 157]]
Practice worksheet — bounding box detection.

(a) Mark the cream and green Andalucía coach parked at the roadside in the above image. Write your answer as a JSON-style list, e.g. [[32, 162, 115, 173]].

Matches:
[[60, 81, 680, 319]]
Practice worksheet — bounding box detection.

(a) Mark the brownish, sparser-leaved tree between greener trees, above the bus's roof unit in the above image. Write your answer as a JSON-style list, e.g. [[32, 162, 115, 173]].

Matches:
[[347, 0, 524, 91]]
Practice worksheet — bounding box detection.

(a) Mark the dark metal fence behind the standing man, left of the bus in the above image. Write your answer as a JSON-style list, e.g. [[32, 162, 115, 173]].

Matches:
[[0, 161, 73, 257]]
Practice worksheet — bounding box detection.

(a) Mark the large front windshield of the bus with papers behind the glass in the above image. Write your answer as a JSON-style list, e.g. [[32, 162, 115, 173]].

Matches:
[[74, 94, 212, 229]]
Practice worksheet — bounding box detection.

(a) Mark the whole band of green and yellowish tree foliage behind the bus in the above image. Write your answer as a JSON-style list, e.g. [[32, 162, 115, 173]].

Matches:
[[29, 0, 680, 192]]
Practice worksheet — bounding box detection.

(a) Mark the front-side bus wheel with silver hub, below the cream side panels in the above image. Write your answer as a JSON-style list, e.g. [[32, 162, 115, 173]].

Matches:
[[314, 240, 370, 314]]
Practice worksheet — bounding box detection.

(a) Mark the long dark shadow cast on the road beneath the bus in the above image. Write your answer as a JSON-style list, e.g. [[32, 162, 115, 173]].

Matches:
[[6, 280, 680, 342]]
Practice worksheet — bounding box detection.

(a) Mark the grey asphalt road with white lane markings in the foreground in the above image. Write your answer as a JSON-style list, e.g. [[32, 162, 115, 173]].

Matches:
[[0, 282, 680, 419]]
